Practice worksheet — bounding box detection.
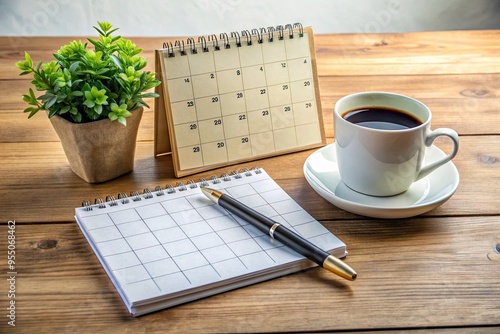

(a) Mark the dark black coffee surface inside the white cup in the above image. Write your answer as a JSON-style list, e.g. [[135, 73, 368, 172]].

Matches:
[[342, 107, 422, 130]]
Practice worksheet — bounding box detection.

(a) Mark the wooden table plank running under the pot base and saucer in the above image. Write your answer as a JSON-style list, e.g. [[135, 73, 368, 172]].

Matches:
[[0, 136, 500, 223]]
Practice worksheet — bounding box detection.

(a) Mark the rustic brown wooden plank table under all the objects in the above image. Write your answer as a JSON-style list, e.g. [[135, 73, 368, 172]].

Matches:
[[0, 31, 500, 333]]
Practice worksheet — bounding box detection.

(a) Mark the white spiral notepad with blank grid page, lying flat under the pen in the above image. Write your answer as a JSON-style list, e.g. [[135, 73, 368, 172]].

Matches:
[[75, 169, 347, 316]]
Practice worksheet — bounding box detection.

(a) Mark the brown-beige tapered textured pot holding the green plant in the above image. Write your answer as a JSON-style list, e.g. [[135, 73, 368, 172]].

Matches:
[[50, 108, 143, 183]]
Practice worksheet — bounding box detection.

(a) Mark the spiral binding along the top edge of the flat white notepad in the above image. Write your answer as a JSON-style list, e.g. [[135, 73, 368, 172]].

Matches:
[[82, 167, 262, 211]]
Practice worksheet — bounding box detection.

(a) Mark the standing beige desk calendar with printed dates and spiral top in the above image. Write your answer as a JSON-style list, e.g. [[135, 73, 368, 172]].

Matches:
[[155, 24, 326, 177]]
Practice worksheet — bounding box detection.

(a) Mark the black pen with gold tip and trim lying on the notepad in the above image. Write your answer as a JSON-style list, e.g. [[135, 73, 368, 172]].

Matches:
[[201, 187, 357, 281]]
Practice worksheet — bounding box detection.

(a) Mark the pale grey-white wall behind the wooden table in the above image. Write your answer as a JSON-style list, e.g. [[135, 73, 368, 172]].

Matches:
[[0, 0, 500, 36]]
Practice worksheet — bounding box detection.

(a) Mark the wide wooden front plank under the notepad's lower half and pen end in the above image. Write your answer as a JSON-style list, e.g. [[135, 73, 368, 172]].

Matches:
[[1, 217, 500, 333]]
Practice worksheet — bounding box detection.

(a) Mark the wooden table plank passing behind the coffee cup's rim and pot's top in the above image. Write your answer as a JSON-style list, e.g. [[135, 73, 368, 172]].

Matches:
[[0, 74, 500, 142]]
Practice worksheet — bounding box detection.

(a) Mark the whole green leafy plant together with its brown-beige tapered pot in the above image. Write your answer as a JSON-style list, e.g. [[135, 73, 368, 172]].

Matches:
[[16, 22, 160, 183]]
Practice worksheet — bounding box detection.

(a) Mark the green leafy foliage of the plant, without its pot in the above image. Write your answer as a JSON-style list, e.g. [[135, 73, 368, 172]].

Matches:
[[16, 22, 160, 125]]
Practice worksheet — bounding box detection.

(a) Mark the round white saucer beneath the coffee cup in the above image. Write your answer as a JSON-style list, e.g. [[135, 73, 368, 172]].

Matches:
[[304, 143, 460, 218]]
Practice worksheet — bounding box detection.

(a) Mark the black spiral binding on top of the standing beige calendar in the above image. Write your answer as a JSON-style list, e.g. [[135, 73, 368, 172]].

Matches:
[[163, 23, 304, 57]]
